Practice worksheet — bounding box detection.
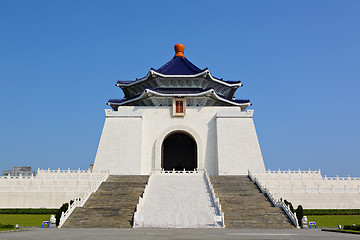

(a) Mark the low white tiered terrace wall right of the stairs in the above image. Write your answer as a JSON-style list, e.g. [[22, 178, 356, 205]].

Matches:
[[255, 170, 360, 209]]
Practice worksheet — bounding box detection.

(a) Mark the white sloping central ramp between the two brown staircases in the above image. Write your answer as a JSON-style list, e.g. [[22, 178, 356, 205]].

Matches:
[[134, 172, 222, 228]]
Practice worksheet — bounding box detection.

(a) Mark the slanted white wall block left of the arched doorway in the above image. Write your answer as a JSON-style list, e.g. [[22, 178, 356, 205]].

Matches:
[[94, 109, 143, 175]]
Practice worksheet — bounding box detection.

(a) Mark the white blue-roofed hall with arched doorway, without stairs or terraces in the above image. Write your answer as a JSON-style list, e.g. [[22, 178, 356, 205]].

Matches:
[[94, 44, 265, 175]]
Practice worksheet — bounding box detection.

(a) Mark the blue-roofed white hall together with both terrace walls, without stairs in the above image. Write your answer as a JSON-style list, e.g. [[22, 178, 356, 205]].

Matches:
[[0, 44, 360, 209]]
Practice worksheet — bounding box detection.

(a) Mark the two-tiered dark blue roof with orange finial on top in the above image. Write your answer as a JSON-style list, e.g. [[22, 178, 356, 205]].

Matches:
[[108, 44, 250, 108]]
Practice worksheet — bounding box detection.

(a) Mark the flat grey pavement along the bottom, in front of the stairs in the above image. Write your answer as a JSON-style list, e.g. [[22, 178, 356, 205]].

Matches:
[[0, 228, 359, 240]]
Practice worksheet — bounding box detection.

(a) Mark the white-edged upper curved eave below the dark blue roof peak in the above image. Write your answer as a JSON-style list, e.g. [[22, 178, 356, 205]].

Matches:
[[116, 70, 243, 88]]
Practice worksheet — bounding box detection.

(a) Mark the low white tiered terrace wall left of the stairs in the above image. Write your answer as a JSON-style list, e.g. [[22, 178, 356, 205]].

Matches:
[[0, 170, 107, 208]]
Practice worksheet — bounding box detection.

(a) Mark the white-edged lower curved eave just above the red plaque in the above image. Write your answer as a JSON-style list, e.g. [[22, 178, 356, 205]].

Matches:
[[108, 89, 251, 107]]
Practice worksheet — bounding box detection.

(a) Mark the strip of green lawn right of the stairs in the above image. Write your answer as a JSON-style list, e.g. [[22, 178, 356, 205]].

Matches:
[[307, 215, 360, 228]]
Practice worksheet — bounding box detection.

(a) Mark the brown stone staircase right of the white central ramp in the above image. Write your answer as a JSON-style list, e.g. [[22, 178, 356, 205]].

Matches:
[[210, 176, 294, 229]]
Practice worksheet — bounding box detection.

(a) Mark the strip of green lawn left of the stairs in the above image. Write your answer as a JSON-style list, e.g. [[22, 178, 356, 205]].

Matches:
[[0, 214, 51, 227]]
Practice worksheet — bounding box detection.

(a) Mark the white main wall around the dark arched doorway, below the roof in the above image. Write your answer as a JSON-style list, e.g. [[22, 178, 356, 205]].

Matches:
[[94, 106, 265, 175]]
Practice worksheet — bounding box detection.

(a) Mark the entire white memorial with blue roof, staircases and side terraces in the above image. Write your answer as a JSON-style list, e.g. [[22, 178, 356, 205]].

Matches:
[[0, 44, 360, 229]]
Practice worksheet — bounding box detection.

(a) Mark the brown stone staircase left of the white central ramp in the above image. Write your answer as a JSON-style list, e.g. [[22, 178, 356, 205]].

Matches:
[[62, 175, 149, 228]]
